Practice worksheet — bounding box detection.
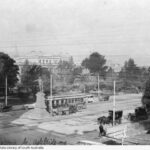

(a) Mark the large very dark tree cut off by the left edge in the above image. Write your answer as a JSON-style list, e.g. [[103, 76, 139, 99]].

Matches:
[[0, 52, 19, 88]]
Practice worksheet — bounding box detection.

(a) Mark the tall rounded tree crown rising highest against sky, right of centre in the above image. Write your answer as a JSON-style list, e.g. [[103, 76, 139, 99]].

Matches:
[[82, 52, 107, 77]]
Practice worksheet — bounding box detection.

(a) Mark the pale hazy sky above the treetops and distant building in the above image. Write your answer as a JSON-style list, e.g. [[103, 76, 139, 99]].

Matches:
[[0, 0, 150, 66]]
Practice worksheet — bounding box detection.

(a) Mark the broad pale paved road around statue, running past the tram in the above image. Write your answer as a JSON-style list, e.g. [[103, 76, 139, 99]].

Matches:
[[0, 95, 145, 144]]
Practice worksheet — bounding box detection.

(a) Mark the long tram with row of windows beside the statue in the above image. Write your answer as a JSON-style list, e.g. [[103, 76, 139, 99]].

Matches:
[[46, 94, 87, 115]]
